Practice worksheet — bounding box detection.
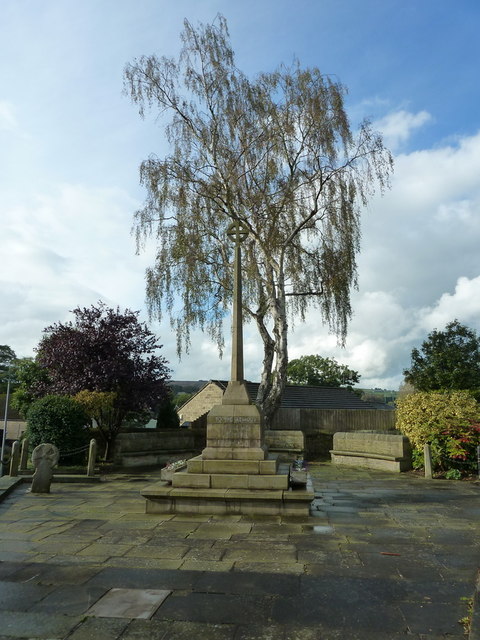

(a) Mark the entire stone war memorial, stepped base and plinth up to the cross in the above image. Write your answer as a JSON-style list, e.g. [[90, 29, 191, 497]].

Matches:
[[141, 223, 314, 516]]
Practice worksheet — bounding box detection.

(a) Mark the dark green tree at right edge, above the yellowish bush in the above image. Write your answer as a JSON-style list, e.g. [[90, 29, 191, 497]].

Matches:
[[403, 320, 480, 396]]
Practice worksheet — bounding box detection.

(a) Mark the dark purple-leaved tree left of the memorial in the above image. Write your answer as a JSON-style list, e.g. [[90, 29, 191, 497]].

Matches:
[[31, 302, 170, 458]]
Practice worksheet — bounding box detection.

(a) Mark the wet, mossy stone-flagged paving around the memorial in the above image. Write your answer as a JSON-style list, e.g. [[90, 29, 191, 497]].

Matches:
[[0, 463, 480, 640]]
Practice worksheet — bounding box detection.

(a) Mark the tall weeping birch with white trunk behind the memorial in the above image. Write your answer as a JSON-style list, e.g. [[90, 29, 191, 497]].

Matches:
[[124, 16, 392, 423]]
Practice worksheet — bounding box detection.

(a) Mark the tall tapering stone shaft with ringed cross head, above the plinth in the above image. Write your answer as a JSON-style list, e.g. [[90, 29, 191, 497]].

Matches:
[[227, 220, 248, 382]]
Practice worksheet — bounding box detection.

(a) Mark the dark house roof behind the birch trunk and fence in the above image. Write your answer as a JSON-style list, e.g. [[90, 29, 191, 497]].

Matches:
[[205, 380, 390, 410]]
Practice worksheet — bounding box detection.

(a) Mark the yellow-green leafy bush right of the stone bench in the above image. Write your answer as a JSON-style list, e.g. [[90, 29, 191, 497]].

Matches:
[[396, 391, 480, 474]]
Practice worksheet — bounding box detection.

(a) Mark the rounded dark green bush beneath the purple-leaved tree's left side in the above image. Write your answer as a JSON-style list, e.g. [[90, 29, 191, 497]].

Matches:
[[27, 395, 90, 464]]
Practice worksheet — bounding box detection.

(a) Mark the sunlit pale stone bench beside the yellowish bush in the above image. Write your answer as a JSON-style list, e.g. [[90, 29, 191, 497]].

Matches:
[[330, 431, 412, 472]]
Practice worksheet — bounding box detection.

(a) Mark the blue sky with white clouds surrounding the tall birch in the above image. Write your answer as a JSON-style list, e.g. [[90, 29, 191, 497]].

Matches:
[[0, 0, 480, 388]]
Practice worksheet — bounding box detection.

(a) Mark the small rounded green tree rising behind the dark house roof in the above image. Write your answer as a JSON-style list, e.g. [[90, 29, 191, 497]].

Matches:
[[287, 355, 360, 389]]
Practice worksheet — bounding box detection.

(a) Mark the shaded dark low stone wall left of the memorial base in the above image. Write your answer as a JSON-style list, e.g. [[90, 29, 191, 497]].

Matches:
[[113, 429, 196, 467]]
